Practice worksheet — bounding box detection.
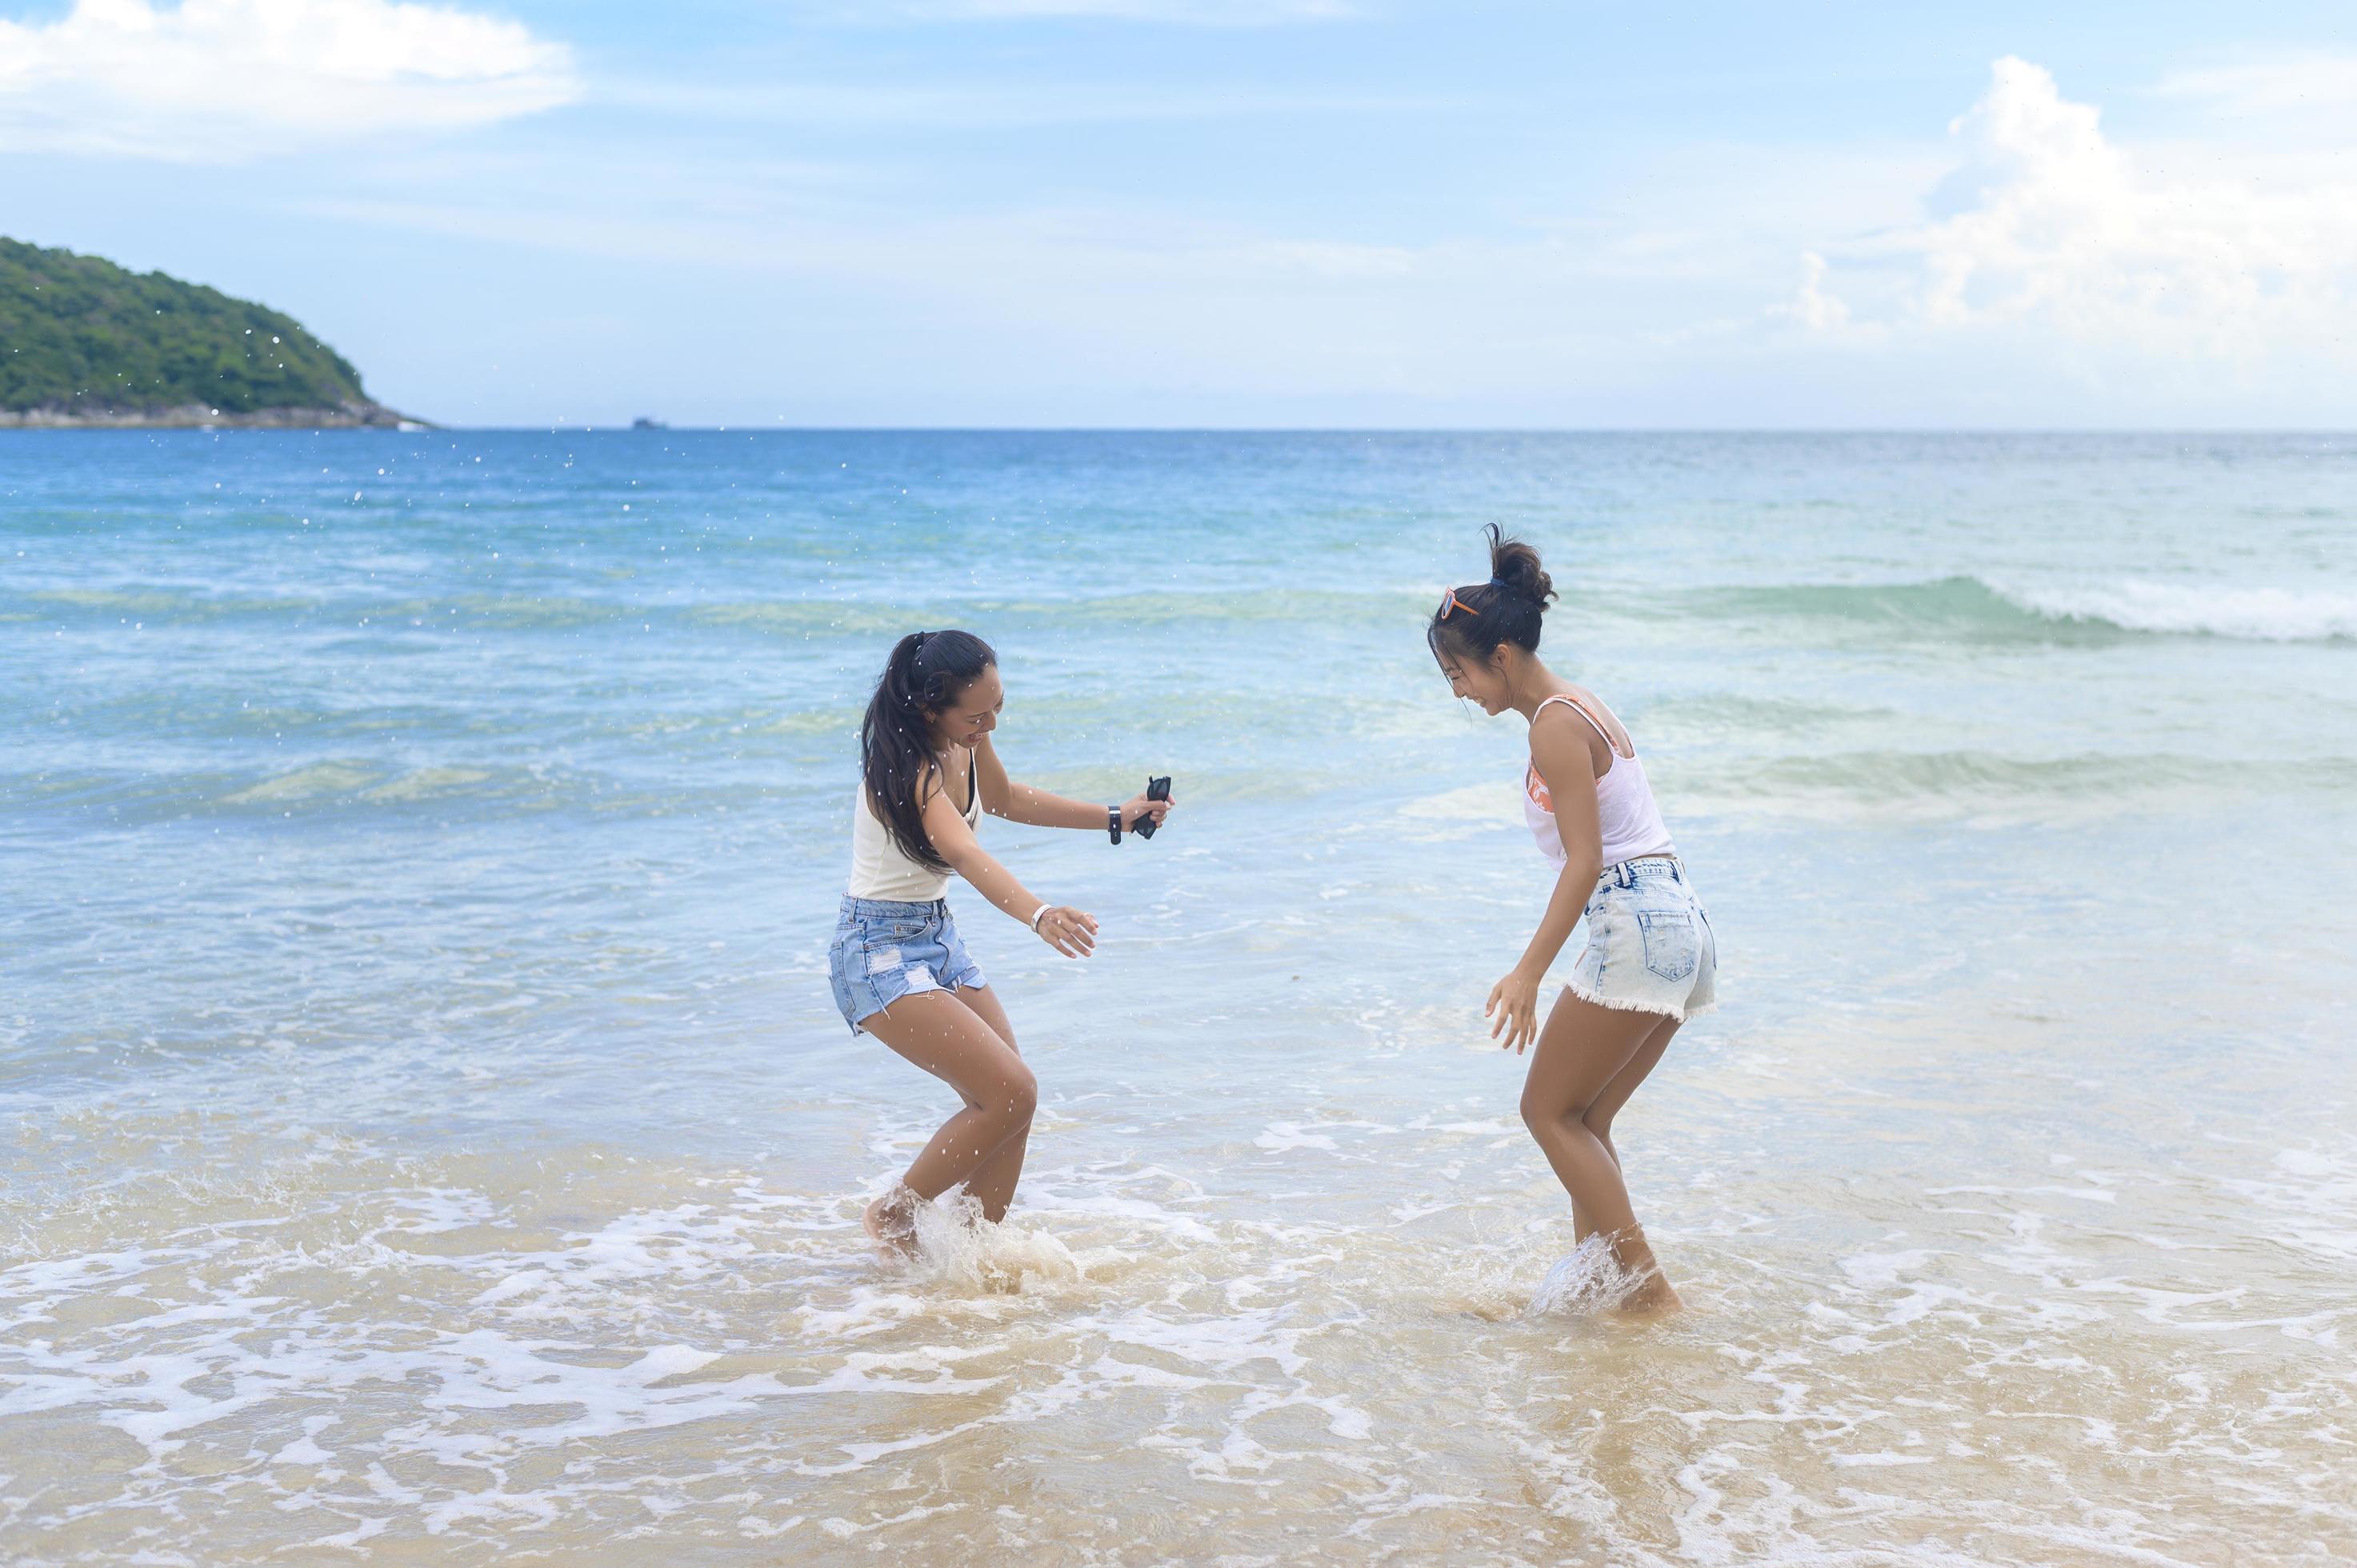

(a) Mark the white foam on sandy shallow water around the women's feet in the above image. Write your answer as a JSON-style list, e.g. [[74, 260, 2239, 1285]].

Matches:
[[0, 1108, 2357, 1563]]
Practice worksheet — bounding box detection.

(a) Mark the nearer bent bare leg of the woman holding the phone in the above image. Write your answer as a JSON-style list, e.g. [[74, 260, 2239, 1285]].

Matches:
[[862, 990, 1039, 1254]]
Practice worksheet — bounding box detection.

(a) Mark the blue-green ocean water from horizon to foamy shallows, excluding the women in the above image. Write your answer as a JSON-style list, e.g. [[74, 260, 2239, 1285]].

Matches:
[[0, 431, 2357, 1566]]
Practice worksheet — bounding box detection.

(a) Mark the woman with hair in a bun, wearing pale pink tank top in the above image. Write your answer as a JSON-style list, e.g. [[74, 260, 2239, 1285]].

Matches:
[[1426, 526, 1719, 1311]]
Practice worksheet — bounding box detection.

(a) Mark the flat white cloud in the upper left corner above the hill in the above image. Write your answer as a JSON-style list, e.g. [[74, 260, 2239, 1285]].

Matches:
[[0, 0, 580, 162]]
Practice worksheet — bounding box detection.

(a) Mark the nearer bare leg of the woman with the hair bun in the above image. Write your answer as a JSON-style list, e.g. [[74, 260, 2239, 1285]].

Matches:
[[1523, 990, 1679, 1311]]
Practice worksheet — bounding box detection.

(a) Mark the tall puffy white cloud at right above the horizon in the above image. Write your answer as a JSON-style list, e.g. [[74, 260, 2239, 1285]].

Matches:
[[1779, 57, 2357, 375]]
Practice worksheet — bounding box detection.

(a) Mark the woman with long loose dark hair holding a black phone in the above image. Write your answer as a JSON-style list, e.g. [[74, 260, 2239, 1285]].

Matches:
[[827, 632, 1171, 1257]]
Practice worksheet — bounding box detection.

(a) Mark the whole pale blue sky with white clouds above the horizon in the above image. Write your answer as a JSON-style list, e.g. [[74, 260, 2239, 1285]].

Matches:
[[0, 0, 2357, 429]]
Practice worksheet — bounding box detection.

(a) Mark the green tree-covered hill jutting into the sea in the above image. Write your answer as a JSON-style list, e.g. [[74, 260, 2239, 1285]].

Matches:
[[0, 238, 403, 426]]
